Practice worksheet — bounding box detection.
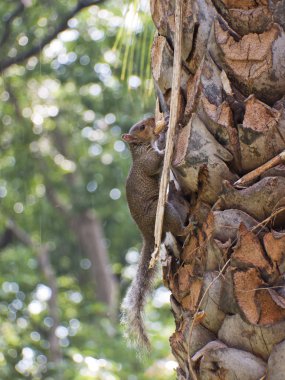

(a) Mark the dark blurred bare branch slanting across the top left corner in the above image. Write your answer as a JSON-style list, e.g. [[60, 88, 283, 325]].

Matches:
[[0, 0, 105, 73]]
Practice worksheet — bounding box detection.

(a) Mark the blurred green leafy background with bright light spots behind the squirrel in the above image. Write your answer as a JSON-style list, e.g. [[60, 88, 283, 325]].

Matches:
[[0, 0, 175, 380]]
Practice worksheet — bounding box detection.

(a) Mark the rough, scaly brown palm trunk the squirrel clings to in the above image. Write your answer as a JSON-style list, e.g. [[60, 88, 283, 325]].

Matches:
[[151, 0, 285, 380]]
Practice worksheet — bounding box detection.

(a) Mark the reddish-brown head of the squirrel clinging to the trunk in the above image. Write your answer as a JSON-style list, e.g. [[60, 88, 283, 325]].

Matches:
[[122, 117, 158, 144]]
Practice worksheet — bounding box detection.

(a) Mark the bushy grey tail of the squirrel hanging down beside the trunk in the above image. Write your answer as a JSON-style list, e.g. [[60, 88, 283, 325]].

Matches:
[[121, 242, 155, 351]]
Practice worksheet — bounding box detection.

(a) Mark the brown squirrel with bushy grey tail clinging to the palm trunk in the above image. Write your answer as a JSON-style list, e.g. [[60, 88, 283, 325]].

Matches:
[[122, 118, 190, 349]]
